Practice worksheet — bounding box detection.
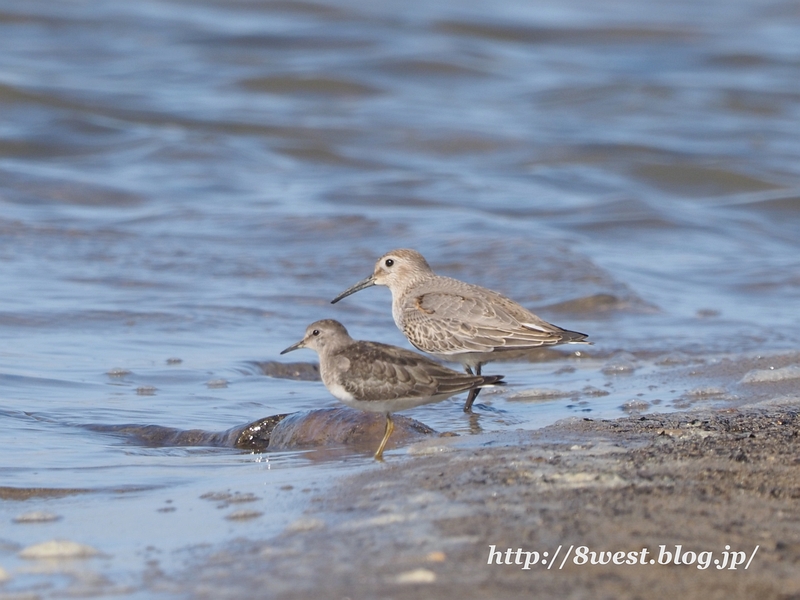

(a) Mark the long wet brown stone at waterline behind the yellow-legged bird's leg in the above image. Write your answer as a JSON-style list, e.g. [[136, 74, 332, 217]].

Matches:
[[84, 407, 436, 452]]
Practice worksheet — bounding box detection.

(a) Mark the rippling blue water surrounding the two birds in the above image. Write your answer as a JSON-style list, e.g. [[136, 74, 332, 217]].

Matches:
[[0, 0, 800, 597]]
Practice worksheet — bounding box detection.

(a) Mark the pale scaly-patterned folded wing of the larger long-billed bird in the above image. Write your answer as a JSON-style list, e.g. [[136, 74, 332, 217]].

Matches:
[[402, 277, 586, 354]]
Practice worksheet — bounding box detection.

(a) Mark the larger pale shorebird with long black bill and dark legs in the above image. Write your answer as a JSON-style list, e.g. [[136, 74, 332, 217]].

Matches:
[[331, 249, 591, 412]]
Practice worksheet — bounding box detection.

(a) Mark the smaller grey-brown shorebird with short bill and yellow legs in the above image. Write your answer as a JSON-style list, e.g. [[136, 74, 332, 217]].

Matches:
[[281, 319, 503, 460]]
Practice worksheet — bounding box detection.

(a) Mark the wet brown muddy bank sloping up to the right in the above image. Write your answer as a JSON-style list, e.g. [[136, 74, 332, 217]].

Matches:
[[180, 403, 800, 600]]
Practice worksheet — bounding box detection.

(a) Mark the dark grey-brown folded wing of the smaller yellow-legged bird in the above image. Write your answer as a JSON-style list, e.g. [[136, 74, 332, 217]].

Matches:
[[338, 342, 489, 401]]
